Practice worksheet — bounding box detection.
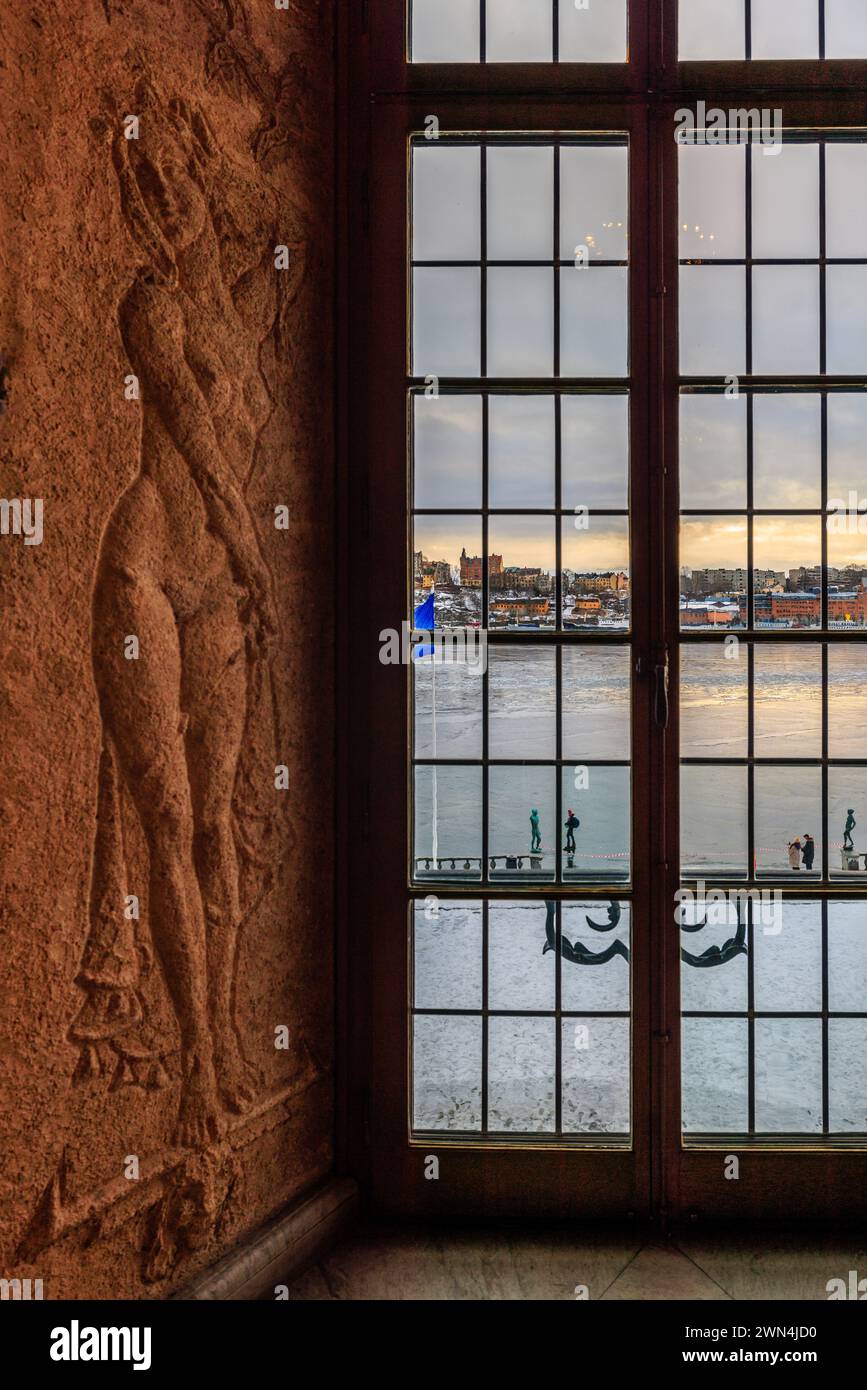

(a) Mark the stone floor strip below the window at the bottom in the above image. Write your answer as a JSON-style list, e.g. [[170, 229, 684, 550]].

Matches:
[[283, 1223, 867, 1301]]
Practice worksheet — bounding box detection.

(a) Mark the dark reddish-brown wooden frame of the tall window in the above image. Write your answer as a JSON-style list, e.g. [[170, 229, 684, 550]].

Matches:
[[338, 0, 867, 1220]]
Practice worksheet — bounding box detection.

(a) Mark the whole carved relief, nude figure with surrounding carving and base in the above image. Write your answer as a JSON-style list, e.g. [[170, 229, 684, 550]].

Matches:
[[2, 0, 329, 1283]]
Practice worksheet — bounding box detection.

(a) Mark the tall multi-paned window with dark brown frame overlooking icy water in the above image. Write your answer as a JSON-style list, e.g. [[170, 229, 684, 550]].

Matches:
[[360, 0, 867, 1215]]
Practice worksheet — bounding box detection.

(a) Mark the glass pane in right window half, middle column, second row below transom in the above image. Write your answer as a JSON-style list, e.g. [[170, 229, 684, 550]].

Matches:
[[753, 265, 816, 375]]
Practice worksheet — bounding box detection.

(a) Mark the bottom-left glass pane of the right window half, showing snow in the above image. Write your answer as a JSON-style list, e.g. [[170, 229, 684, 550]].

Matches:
[[682, 1019, 749, 1134]]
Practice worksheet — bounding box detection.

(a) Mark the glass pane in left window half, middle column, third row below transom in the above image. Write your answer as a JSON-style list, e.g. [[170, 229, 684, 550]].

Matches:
[[488, 396, 554, 507]]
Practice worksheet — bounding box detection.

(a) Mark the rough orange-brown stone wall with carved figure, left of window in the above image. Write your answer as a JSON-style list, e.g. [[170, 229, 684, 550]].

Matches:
[[0, 0, 333, 1298]]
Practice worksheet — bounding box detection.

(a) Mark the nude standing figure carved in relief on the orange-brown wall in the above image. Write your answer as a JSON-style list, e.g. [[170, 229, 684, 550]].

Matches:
[[69, 79, 302, 1148]]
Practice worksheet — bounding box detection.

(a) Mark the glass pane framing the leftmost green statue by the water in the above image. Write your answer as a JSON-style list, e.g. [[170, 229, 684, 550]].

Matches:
[[488, 763, 557, 883]]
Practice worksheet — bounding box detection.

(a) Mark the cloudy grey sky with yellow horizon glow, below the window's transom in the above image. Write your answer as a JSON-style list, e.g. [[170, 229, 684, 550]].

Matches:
[[413, 136, 867, 570]]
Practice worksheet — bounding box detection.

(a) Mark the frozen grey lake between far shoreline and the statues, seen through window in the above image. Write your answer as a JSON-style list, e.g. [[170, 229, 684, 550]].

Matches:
[[414, 642, 867, 876]]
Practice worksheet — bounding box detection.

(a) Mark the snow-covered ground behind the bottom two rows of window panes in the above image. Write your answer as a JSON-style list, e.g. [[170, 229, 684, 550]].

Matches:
[[414, 901, 867, 1134]]
